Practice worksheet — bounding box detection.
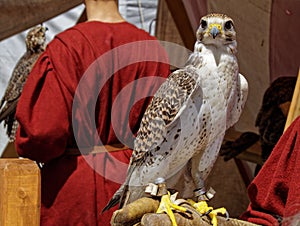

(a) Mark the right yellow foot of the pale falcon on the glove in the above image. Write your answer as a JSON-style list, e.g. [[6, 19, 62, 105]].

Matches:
[[188, 199, 228, 226]]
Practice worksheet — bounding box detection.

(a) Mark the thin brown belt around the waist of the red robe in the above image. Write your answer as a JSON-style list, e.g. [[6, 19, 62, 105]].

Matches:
[[65, 143, 129, 155]]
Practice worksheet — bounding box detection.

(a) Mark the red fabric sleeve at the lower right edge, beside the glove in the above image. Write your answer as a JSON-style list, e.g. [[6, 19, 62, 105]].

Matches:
[[240, 117, 300, 226]]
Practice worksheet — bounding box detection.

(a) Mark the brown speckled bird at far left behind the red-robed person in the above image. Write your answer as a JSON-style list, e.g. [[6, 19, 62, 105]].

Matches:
[[0, 25, 47, 142]]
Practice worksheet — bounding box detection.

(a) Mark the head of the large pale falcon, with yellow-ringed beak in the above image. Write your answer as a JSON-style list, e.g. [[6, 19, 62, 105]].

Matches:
[[197, 13, 236, 46]]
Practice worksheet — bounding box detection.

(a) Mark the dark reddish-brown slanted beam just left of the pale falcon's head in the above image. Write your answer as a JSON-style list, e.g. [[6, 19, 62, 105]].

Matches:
[[165, 0, 196, 51]]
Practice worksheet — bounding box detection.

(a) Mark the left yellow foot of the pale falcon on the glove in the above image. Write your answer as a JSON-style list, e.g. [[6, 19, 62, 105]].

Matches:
[[156, 192, 190, 226]]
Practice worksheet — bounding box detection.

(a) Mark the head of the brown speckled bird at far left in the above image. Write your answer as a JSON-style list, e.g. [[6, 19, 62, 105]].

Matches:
[[25, 25, 48, 52]]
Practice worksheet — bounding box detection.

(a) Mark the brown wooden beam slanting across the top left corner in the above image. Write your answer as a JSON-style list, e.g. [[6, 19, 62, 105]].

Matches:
[[0, 0, 82, 40]]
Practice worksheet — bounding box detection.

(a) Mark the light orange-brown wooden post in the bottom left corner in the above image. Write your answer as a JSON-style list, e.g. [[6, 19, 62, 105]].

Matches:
[[0, 158, 41, 226]]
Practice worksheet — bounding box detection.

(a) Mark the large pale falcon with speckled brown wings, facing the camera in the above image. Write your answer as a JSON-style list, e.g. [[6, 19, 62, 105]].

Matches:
[[105, 14, 248, 225]]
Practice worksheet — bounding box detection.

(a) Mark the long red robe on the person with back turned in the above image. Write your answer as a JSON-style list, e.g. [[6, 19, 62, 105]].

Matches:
[[16, 21, 169, 226]]
